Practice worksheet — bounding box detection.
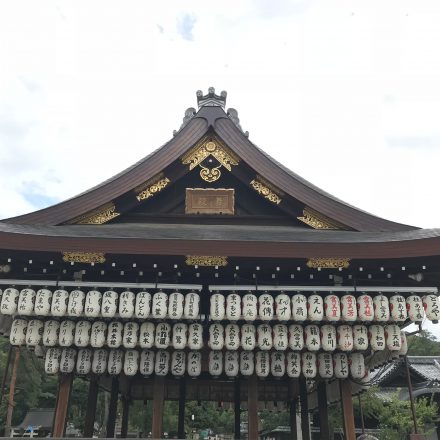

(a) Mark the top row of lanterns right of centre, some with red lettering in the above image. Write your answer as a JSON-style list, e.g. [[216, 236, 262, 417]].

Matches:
[[210, 293, 440, 322]]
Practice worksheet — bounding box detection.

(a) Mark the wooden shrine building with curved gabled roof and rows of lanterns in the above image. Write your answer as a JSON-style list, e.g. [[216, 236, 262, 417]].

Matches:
[[0, 88, 440, 440]]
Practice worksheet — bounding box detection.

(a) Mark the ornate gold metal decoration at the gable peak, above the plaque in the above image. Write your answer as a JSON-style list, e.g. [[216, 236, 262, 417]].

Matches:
[[182, 139, 239, 182]]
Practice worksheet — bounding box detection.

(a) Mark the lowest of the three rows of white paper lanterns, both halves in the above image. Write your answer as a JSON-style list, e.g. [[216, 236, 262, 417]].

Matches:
[[45, 348, 366, 379]]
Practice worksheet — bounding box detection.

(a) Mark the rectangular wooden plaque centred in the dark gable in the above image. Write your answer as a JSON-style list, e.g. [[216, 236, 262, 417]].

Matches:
[[185, 188, 235, 215]]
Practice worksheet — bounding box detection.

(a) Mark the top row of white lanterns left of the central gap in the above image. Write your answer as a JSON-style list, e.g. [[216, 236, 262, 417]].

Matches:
[[0, 287, 200, 319]]
